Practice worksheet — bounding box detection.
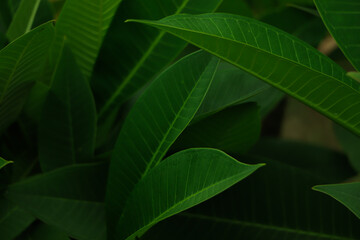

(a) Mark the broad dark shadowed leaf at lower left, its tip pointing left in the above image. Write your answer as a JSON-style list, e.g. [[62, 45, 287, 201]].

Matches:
[[6, 163, 107, 240]]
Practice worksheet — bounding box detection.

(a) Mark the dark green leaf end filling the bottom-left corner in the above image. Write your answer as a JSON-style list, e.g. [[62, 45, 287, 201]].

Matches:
[[0, 197, 35, 240]]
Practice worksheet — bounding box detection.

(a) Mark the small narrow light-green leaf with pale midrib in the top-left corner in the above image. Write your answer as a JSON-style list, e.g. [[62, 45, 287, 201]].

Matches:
[[6, 0, 41, 41]]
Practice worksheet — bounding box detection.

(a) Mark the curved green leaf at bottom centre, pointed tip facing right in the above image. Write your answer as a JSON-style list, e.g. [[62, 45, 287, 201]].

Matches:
[[116, 149, 262, 239]]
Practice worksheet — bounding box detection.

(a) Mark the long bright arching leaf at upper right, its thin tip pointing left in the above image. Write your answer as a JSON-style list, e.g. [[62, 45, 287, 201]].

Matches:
[[129, 13, 360, 135]]
